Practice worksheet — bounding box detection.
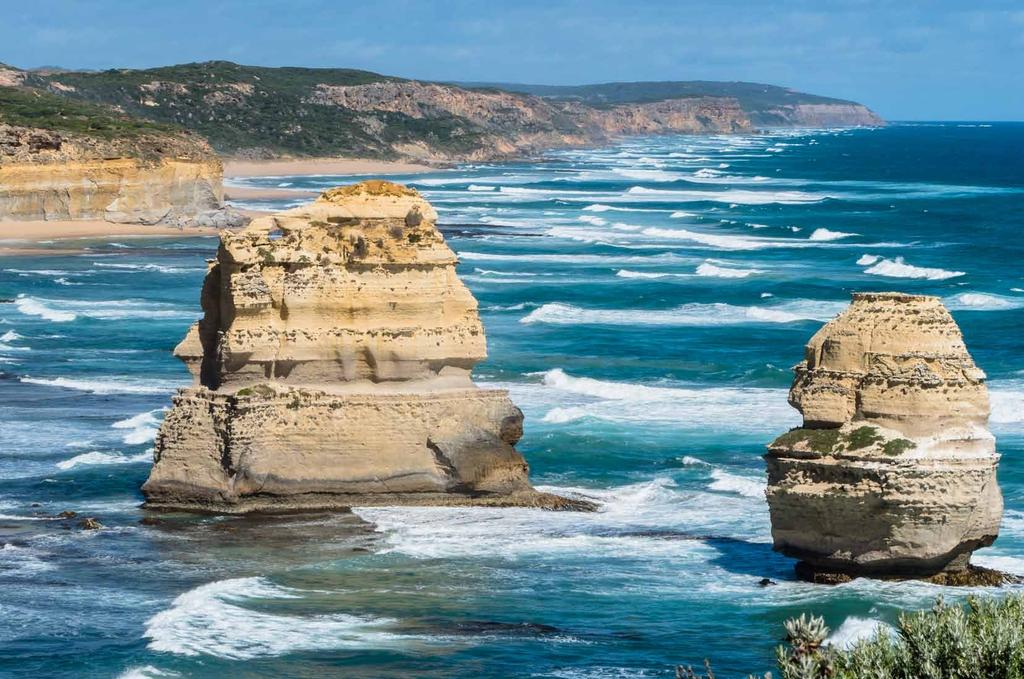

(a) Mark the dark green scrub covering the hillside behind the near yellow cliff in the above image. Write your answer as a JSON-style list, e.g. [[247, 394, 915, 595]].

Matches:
[[16, 61, 454, 158]]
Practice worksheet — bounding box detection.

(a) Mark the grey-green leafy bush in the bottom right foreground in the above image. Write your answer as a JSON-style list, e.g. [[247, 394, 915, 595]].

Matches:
[[676, 595, 1024, 679]]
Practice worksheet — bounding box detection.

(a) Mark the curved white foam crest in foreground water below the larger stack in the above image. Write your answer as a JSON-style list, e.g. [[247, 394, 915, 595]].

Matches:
[[143, 578, 401, 660]]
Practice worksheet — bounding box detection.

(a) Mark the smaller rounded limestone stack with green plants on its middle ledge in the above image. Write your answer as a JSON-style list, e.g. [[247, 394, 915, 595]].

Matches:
[[765, 293, 1002, 582]]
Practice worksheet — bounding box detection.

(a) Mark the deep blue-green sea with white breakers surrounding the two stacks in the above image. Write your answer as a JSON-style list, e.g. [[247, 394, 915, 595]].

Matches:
[[0, 124, 1024, 678]]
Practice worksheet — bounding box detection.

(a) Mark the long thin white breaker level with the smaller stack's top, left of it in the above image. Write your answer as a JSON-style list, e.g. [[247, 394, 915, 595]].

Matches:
[[519, 299, 845, 327]]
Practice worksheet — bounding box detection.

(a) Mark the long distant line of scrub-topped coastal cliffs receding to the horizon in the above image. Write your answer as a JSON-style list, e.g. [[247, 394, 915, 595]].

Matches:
[[16, 61, 882, 162]]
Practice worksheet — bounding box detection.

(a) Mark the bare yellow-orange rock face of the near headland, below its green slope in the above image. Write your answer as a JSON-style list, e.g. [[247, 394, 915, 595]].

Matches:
[[0, 124, 223, 224]]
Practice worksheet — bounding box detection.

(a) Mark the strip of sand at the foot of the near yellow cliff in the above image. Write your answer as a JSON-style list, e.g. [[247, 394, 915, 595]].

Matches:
[[0, 219, 217, 256]]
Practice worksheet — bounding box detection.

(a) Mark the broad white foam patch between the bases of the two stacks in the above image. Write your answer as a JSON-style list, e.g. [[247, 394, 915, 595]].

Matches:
[[353, 477, 767, 571]]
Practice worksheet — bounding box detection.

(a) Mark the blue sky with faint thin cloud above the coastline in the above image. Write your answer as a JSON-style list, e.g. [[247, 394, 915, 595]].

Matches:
[[0, 0, 1024, 120]]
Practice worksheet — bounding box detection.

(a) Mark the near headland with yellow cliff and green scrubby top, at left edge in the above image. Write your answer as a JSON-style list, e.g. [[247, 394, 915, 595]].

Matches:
[[0, 87, 223, 224]]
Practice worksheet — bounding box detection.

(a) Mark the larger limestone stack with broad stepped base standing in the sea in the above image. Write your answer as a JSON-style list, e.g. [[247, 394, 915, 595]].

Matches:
[[142, 181, 584, 512]]
